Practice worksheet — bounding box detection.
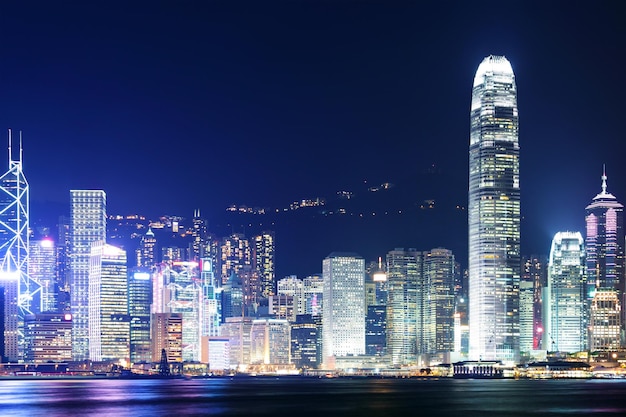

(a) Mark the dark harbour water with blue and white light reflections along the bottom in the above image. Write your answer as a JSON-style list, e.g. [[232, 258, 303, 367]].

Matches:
[[0, 378, 626, 417]]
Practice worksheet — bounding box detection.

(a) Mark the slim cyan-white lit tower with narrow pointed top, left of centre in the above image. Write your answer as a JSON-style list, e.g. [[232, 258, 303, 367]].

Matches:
[[200, 258, 222, 337]]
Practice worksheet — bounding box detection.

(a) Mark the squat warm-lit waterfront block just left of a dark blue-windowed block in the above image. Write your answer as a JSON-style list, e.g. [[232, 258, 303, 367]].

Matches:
[[250, 318, 291, 369]]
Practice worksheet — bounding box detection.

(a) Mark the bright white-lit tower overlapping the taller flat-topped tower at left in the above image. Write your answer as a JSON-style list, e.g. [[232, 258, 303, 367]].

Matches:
[[88, 241, 130, 362]]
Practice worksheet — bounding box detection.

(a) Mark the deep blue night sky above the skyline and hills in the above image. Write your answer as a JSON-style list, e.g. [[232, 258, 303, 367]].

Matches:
[[0, 0, 626, 275]]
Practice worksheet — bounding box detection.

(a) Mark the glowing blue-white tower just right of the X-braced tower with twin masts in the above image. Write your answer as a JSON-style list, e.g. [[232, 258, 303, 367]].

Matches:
[[28, 238, 58, 313]]
